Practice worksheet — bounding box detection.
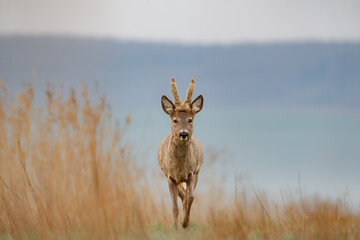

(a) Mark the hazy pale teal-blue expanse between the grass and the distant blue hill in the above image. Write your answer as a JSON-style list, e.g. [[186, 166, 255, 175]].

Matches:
[[114, 106, 360, 207]]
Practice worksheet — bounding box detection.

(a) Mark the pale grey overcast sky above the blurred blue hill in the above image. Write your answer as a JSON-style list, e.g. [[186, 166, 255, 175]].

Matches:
[[0, 0, 360, 44]]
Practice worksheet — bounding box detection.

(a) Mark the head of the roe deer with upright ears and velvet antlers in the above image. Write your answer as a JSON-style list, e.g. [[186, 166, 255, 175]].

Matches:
[[161, 78, 204, 142]]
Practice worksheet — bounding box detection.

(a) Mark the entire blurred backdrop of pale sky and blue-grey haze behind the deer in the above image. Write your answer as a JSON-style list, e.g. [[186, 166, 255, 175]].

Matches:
[[0, 0, 360, 207]]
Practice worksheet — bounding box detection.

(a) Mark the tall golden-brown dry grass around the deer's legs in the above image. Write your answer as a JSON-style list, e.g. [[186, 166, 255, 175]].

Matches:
[[0, 82, 360, 239]]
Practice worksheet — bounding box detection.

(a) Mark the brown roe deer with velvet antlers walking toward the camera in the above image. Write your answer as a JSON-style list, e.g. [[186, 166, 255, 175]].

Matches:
[[158, 78, 204, 229]]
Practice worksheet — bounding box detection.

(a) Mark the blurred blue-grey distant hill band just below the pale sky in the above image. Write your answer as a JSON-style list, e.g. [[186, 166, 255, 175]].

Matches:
[[0, 36, 360, 108]]
